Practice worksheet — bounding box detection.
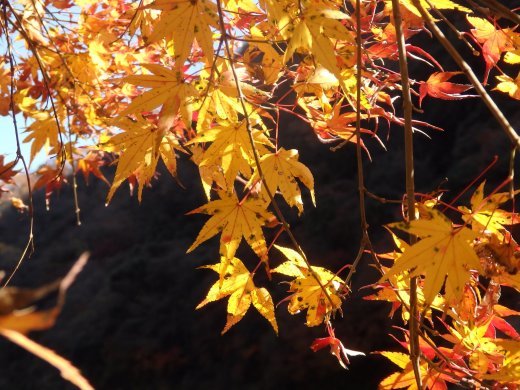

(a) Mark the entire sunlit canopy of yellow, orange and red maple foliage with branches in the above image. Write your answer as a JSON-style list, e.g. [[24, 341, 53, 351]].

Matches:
[[0, 0, 520, 389]]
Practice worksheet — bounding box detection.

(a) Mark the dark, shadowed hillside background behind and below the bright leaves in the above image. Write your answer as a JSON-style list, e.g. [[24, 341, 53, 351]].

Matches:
[[0, 88, 519, 389]]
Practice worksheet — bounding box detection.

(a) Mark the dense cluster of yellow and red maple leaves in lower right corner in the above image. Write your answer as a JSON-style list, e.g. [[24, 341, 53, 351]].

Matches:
[[372, 182, 520, 389]]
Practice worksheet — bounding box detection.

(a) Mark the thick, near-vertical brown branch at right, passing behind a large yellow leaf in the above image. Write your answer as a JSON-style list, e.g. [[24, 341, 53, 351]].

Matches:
[[392, 0, 422, 389]]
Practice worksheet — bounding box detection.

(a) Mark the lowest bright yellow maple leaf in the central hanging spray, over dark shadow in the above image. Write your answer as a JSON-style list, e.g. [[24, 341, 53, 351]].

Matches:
[[197, 257, 278, 334]]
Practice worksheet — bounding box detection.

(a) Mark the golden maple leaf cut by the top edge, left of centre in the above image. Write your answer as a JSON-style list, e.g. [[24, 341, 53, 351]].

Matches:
[[145, 0, 218, 69]]
